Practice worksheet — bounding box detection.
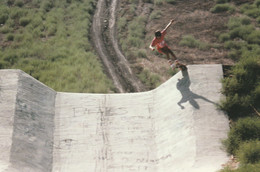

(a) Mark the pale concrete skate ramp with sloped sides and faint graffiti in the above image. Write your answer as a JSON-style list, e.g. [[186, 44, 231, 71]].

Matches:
[[0, 65, 229, 172]]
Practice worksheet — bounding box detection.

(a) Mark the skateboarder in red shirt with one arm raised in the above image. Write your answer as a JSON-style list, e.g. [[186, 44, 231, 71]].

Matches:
[[149, 20, 177, 61]]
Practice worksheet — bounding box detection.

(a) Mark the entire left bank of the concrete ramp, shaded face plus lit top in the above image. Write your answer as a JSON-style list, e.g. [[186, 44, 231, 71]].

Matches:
[[0, 70, 56, 172]]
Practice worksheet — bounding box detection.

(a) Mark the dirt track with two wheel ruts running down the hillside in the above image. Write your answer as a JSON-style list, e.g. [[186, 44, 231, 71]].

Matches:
[[92, 0, 145, 93]]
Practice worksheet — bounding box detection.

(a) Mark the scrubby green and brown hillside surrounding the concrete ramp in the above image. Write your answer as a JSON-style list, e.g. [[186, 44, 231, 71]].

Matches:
[[0, 0, 260, 171]]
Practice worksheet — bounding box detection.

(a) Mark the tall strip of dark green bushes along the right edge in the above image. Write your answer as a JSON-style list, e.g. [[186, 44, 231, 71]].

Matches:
[[219, 0, 260, 172]]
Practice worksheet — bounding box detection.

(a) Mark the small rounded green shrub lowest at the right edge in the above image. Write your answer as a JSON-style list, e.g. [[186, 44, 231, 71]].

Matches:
[[236, 140, 260, 164]]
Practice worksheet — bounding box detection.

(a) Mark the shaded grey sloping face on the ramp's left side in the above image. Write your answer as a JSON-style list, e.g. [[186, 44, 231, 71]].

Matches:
[[9, 73, 56, 172]]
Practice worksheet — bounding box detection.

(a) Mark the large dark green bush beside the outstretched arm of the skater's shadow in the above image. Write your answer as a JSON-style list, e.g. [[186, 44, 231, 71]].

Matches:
[[221, 53, 260, 118]]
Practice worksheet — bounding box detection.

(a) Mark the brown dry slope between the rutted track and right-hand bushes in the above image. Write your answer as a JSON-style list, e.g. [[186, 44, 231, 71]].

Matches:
[[115, 0, 236, 83]]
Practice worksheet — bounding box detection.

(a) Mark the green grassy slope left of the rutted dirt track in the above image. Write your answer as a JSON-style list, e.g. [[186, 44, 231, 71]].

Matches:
[[0, 0, 113, 93]]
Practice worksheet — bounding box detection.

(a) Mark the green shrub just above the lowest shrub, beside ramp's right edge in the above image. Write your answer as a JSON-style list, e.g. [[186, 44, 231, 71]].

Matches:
[[224, 117, 260, 154]]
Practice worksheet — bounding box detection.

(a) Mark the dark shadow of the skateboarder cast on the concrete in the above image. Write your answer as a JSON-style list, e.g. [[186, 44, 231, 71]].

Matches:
[[177, 70, 216, 109]]
